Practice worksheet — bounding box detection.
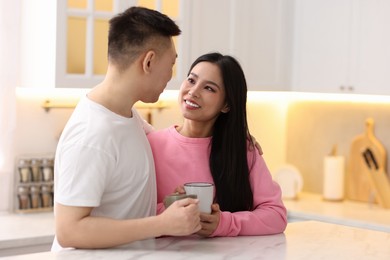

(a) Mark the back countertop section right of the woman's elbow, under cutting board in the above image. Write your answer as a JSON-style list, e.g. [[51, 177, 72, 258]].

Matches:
[[284, 193, 390, 232]]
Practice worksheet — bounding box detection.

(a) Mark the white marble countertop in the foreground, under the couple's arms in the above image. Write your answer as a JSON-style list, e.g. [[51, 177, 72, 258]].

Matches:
[[3, 221, 390, 260]]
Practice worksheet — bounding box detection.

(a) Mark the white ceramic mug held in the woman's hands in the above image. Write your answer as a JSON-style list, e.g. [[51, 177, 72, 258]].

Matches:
[[184, 182, 214, 214]]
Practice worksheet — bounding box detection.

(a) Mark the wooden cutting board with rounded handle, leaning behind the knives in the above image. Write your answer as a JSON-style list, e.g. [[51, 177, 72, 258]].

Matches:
[[346, 118, 387, 202]]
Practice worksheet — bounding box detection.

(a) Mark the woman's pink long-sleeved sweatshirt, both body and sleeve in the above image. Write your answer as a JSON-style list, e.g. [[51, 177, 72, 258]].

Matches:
[[148, 126, 287, 236]]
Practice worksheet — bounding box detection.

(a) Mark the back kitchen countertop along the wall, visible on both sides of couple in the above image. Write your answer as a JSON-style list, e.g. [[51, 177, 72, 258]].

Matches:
[[0, 193, 390, 257]]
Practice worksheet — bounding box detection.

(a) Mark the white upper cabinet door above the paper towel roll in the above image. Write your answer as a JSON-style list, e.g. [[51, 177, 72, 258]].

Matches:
[[292, 0, 353, 92]]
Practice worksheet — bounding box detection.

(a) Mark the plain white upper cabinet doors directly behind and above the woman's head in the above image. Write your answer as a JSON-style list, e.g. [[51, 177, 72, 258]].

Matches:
[[189, 0, 292, 91]]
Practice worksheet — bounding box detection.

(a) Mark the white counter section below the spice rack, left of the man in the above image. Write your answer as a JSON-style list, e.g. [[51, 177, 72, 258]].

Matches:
[[0, 212, 54, 250]]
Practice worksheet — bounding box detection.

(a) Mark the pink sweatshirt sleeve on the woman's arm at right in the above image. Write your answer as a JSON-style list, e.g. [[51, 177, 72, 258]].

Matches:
[[211, 151, 287, 237]]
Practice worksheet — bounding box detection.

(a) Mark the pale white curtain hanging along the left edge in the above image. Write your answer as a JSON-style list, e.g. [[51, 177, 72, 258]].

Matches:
[[0, 0, 21, 211]]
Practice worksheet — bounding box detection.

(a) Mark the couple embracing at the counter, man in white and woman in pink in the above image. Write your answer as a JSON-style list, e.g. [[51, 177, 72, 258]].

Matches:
[[52, 7, 286, 251]]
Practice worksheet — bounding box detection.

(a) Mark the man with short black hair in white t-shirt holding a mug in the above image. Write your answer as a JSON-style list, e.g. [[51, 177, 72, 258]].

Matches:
[[52, 7, 200, 251]]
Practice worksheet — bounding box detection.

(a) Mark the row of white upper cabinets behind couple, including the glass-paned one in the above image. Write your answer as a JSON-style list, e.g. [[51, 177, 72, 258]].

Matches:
[[21, 0, 292, 90]]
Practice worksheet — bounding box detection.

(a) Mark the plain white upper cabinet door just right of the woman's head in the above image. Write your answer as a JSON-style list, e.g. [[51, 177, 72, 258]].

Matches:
[[230, 0, 292, 91]]
